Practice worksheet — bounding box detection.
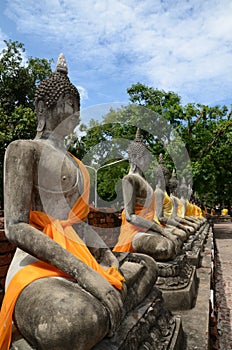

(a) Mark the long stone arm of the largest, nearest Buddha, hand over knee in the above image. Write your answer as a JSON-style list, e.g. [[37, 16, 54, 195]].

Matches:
[[4, 141, 122, 327]]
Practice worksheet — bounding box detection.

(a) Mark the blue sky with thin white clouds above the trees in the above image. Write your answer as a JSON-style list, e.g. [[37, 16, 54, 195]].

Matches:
[[0, 0, 232, 113]]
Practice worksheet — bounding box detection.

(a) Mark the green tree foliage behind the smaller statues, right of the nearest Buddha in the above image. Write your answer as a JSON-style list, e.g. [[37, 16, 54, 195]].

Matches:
[[68, 83, 232, 206]]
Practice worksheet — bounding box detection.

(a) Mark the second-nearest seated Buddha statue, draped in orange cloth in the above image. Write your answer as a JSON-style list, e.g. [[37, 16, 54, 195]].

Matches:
[[113, 129, 182, 261]]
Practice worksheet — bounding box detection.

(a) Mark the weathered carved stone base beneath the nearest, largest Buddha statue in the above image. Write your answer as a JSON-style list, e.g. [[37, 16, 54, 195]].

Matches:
[[93, 287, 185, 350]]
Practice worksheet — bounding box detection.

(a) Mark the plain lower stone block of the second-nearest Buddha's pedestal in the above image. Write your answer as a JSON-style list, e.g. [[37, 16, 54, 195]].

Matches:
[[161, 266, 198, 310]]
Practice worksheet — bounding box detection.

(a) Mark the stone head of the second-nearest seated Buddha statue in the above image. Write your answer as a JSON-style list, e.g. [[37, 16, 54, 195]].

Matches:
[[128, 128, 152, 171]]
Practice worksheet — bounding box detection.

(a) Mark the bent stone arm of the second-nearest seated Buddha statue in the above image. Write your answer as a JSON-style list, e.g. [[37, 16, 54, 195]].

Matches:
[[122, 176, 163, 234]]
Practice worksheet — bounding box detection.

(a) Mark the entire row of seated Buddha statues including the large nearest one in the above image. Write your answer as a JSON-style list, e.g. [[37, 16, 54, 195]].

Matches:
[[0, 55, 207, 350]]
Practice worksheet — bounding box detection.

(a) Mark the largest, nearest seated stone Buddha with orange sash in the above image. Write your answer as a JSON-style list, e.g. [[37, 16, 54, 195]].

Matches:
[[0, 55, 157, 350]]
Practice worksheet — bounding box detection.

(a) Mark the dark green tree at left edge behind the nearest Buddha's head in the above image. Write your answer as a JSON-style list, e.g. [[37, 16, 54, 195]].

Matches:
[[0, 40, 51, 207]]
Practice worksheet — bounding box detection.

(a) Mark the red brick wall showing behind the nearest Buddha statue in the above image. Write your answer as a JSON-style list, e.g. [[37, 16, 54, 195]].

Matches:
[[0, 207, 121, 305]]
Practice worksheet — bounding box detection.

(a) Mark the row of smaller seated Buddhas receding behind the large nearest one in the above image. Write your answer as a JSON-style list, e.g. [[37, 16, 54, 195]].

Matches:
[[113, 138, 205, 261]]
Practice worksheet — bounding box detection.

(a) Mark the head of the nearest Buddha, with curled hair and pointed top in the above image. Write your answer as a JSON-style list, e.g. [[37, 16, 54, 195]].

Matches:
[[35, 54, 80, 136]]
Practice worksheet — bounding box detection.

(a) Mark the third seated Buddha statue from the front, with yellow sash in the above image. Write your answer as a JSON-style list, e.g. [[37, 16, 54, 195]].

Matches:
[[154, 153, 190, 242]]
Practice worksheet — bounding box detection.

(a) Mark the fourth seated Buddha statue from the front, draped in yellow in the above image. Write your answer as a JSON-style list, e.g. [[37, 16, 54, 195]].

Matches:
[[169, 169, 199, 233]]
